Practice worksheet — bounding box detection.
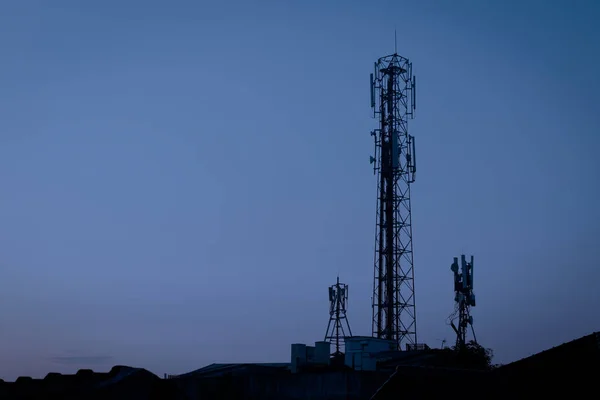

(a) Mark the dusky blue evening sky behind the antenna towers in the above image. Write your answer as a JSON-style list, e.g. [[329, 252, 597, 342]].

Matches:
[[0, 0, 600, 380]]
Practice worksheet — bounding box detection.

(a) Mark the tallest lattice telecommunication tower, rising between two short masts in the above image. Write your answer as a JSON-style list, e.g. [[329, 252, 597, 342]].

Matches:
[[371, 53, 417, 350]]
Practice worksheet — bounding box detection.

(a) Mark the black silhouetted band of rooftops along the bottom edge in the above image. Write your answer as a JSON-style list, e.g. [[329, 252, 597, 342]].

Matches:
[[0, 333, 600, 400]]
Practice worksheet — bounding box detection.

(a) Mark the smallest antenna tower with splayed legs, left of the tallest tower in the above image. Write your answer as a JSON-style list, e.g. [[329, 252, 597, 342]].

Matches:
[[325, 276, 352, 355]]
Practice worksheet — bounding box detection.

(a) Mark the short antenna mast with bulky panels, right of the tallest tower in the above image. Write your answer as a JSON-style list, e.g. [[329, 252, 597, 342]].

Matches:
[[449, 254, 477, 350]]
